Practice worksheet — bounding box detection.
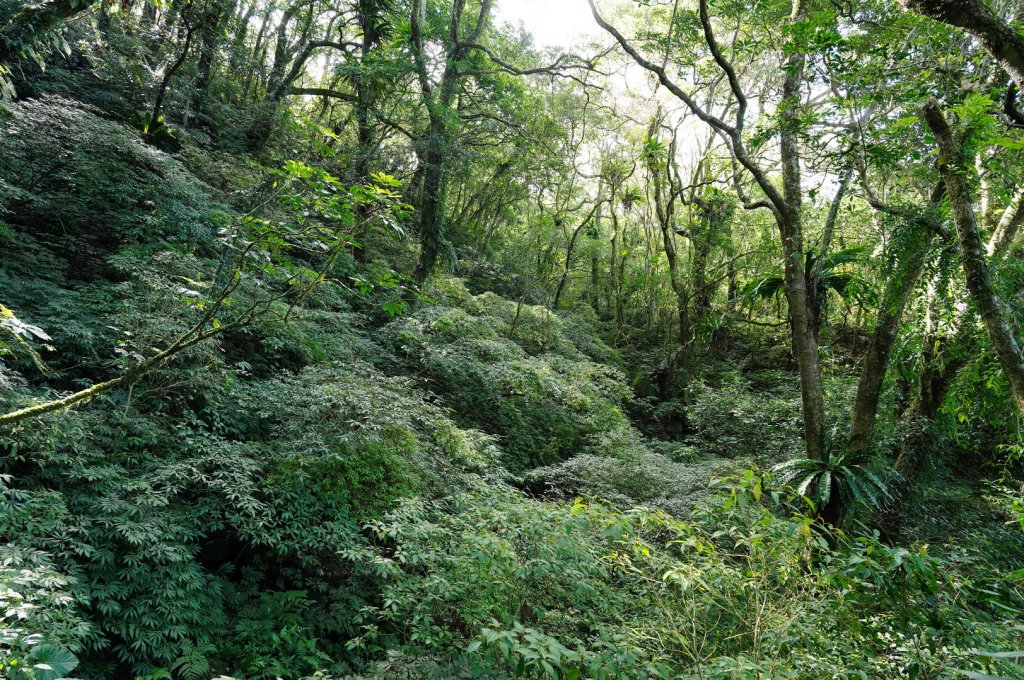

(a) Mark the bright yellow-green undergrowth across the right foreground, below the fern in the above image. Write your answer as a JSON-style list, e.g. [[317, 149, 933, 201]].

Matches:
[[344, 472, 1021, 678]]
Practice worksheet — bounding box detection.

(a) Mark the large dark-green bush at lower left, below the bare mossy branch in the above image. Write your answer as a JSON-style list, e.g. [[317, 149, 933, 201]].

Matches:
[[0, 356, 493, 677]]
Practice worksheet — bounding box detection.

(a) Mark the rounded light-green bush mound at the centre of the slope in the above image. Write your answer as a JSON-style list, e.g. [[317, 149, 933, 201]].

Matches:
[[386, 294, 629, 470]]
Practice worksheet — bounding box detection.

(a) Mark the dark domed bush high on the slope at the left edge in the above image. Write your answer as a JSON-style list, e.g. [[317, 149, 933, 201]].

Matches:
[[0, 96, 217, 261]]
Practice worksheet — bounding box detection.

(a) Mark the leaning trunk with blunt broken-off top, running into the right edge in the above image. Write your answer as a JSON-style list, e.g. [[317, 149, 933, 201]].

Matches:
[[924, 99, 1024, 415]]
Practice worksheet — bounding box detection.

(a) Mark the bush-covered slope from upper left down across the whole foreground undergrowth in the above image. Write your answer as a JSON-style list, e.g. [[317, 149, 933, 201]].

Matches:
[[0, 97, 1012, 678]]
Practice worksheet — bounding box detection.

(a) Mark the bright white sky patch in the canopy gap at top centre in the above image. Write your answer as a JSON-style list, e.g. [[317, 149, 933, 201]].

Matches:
[[497, 0, 599, 49]]
